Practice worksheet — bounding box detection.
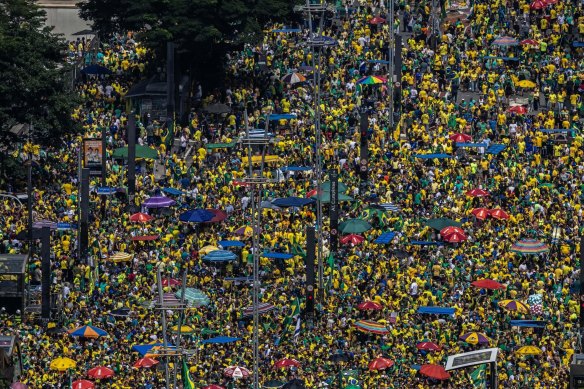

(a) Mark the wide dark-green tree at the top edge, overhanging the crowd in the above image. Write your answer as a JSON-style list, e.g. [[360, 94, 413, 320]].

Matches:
[[77, 0, 296, 83]]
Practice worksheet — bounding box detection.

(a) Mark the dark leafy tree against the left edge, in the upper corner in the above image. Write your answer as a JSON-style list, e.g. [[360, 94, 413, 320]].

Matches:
[[0, 0, 79, 146]]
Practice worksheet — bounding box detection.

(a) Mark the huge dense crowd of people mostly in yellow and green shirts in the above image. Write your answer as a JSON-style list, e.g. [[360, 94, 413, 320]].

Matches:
[[0, 0, 584, 389]]
